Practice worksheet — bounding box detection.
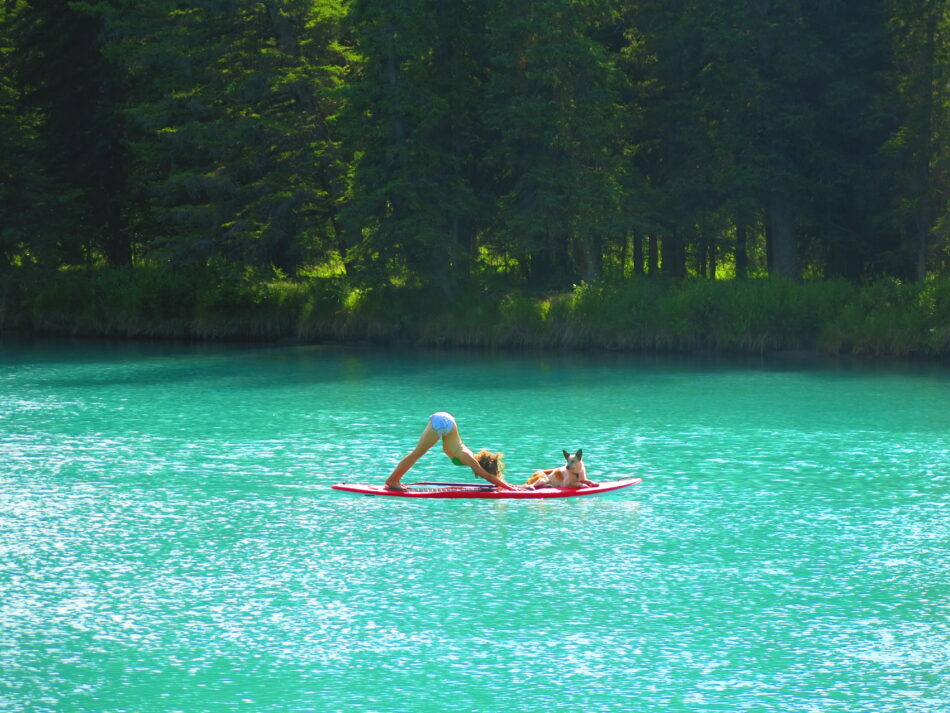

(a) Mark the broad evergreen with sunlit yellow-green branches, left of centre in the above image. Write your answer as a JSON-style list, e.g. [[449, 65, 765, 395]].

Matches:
[[98, 0, 347, 274]]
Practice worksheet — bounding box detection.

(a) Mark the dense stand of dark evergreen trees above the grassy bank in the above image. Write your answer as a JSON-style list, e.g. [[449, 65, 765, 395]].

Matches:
[[0, 0, 950, 295]]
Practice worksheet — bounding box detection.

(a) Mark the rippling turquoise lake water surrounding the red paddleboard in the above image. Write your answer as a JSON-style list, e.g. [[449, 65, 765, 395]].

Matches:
[[0, 341, 950, 713]]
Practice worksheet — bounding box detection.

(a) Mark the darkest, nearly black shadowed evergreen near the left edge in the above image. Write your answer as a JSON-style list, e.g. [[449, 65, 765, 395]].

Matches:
[[8, 0, 132, 265]]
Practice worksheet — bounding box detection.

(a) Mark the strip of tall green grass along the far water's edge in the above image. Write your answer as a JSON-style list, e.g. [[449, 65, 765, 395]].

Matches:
[[0, 266, 950, 356]]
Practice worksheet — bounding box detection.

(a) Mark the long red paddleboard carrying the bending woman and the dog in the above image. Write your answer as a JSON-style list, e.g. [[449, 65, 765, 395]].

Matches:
[[331, 478, 643, 500]]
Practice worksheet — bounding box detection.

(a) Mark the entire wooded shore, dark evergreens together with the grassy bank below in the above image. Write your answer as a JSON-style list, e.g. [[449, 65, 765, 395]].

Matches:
[[0, 0, 950, 355]]
